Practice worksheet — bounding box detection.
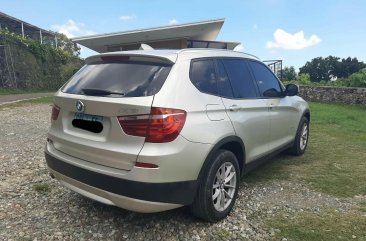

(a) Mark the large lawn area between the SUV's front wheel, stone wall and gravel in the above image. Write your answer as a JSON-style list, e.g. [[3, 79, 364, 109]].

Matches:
[[245, 103, 366, 197]]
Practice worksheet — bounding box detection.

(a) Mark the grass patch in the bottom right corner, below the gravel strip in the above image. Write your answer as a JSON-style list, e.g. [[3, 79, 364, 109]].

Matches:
[[269, 210, 366, 241]]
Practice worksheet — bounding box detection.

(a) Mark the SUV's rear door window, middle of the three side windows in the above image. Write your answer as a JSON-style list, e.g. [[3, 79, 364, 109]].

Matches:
[[222, 59, 257, 99]]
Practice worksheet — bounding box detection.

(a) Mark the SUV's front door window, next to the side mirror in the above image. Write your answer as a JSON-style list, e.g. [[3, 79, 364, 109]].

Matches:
[[249, 61, 282, 97]]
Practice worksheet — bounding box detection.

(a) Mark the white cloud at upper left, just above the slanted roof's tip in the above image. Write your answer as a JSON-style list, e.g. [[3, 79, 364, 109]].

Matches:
[[51, 19, 97, 38]]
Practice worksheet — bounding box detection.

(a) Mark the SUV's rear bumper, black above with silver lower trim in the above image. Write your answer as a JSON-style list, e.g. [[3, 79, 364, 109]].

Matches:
[[45, 151, 197, 212]]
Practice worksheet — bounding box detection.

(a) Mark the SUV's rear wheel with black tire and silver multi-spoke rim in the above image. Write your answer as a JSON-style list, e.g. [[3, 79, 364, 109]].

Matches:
[[191, 150, 240, 222]]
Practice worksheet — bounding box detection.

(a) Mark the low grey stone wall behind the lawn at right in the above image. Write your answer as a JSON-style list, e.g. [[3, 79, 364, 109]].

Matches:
[[299, 85, 366, 105]]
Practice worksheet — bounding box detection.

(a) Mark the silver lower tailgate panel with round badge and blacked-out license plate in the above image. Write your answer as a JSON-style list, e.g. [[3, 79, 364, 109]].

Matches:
[[49, 93, 153, 170]]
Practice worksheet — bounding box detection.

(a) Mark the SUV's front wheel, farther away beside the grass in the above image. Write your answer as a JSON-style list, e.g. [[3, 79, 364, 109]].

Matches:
[[289, 116, 310, 156]]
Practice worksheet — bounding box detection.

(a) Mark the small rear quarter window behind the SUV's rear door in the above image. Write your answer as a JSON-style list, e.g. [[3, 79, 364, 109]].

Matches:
[[190, 59, 217, 95]]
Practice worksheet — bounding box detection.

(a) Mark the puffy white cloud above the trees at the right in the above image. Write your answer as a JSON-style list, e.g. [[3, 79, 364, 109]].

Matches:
[[266, 29, 321, 50]]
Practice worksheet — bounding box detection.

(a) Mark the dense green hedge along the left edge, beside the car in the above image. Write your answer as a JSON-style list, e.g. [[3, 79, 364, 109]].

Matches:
[[0, 30, 83, 90]]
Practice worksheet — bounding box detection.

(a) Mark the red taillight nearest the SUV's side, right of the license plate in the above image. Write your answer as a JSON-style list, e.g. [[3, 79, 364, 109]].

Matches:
[[118, 107, 187, 143]]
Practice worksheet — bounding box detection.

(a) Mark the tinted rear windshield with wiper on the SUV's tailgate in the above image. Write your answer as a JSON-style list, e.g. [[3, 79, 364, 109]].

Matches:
[[62, 61, 171, 97]]
